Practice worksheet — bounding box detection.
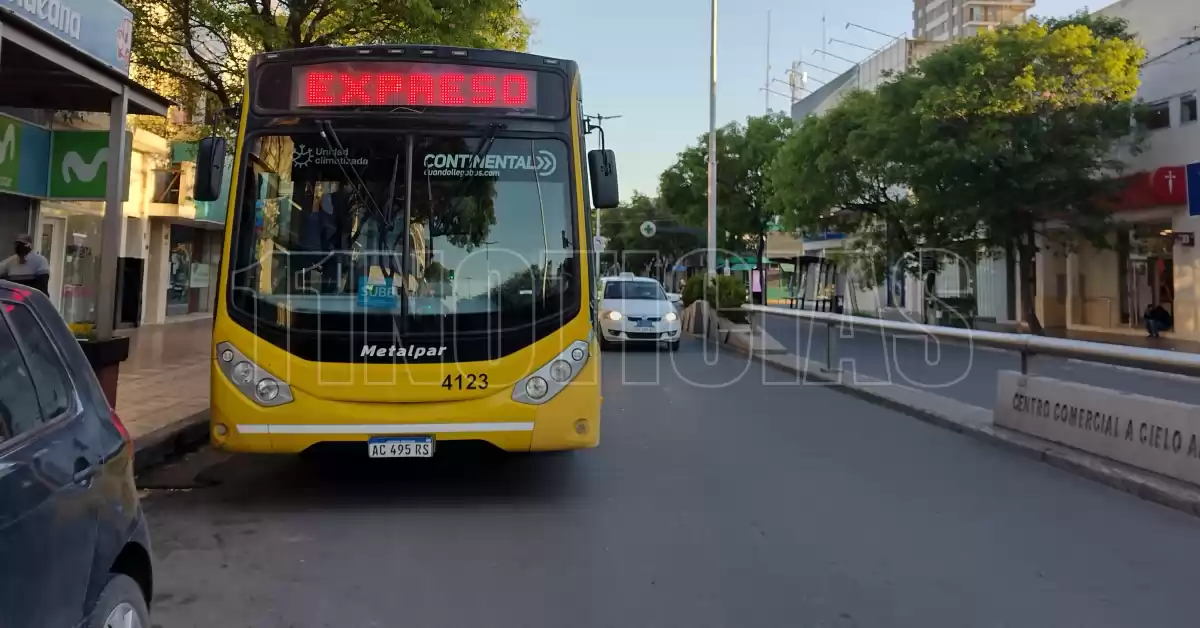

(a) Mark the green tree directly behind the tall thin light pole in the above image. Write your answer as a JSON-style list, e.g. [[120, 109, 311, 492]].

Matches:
[[659, 114, 792, 270]]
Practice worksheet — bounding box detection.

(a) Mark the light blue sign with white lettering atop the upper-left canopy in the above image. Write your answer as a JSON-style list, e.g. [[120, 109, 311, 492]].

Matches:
[[0, 0, 133, 77]]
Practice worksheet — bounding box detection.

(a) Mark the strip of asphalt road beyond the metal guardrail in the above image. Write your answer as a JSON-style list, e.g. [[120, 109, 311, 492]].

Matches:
[[764, 315, 1200, 408]]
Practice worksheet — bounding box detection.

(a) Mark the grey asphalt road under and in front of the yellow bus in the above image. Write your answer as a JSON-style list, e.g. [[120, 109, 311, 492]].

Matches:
[[142, 343, 1200, 628]]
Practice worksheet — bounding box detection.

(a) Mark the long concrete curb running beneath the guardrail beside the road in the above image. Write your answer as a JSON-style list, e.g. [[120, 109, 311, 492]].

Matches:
[[696, 333, 1200, 516]]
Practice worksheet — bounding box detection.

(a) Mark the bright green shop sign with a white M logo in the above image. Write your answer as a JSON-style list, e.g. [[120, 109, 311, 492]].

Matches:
[[47, 131, 133, 201]]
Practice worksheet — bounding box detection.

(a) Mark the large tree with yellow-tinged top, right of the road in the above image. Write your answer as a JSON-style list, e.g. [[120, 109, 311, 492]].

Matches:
[[880, 13, 1145, 334]]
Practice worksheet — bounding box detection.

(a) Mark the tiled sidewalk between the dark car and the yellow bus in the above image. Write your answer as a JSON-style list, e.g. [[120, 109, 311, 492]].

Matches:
[[116, 318, 212, 438]]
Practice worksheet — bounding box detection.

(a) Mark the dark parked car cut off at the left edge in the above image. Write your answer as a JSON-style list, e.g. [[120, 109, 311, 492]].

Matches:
[[0, 281, 152, 628]]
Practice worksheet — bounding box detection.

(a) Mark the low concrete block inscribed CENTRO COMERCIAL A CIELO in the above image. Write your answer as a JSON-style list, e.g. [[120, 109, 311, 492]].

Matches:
[[995, 371, 1200, 484]]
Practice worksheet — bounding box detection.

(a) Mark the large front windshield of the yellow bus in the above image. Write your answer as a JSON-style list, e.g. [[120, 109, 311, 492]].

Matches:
[[230, 127, 578, 334]]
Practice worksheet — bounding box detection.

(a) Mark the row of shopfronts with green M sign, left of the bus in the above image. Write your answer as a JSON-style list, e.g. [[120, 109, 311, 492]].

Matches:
[[0, 109, 224, 328]]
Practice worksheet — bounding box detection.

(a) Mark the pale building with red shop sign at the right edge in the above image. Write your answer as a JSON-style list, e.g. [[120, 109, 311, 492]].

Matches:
[[1038, 0, 1200, 340]]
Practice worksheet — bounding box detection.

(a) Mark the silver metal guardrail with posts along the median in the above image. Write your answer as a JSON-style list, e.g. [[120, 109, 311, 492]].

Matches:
[[742, 305, 1200, 377]]
